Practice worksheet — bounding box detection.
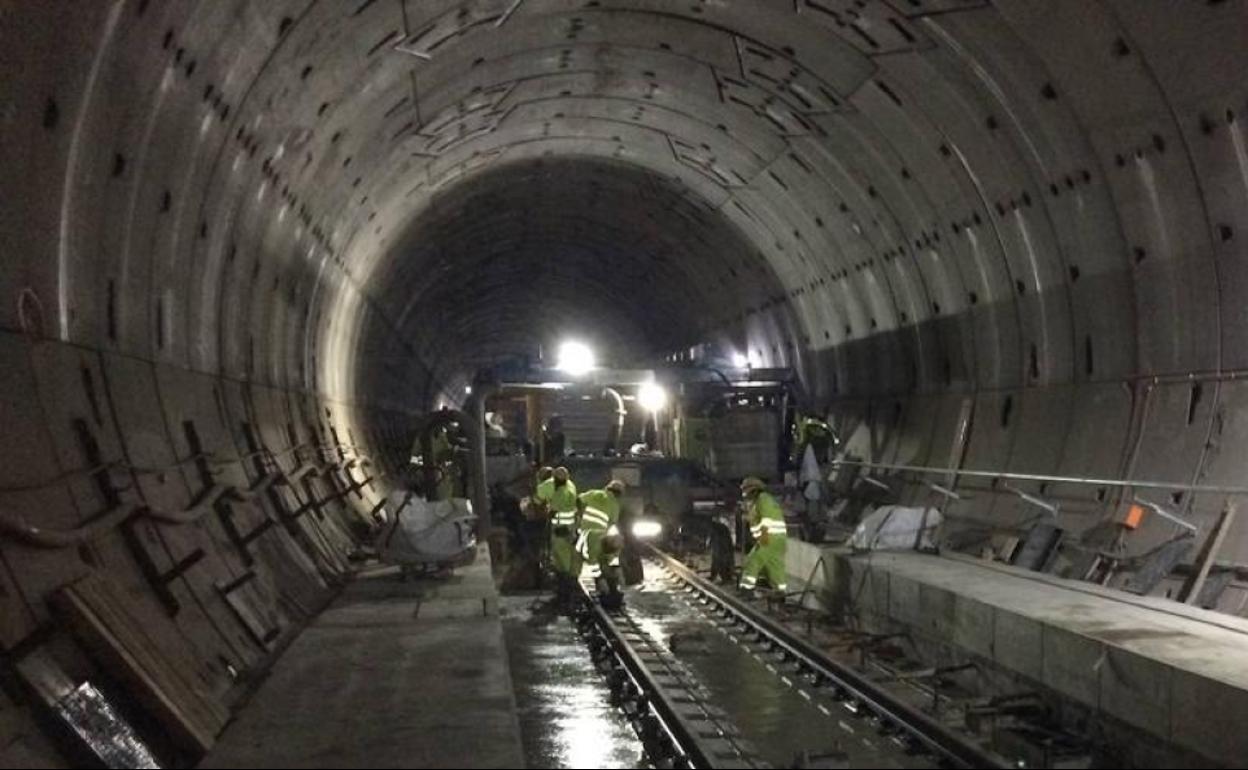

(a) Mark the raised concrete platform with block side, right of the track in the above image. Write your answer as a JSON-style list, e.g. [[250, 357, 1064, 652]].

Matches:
[[789, 543, 1248, 766]]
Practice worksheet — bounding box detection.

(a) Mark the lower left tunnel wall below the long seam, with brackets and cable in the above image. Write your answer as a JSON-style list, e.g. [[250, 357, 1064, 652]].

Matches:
[[0, 331, 409, 765]]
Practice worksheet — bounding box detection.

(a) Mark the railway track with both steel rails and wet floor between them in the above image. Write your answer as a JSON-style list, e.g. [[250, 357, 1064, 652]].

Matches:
[[578, 548, 1008, 768]]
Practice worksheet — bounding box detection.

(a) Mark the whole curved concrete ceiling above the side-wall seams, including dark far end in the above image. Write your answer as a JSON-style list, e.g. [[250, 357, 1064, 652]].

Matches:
[[7, 0, 1248, 559]]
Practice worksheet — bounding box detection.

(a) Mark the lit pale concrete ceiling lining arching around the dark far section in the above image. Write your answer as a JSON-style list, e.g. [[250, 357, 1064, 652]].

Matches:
[[7, 1, 1243, 541]]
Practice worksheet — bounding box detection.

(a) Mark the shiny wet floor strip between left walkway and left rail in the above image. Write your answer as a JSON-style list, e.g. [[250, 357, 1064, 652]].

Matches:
[[499, 597, 648, 768]]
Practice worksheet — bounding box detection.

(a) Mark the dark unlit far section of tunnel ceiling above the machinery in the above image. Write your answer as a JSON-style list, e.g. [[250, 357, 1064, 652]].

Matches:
[[361, 156, 776, 396]]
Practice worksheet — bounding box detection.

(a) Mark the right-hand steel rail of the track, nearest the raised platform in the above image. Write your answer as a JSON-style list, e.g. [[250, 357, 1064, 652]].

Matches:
[[643, 544, 1013, 768]]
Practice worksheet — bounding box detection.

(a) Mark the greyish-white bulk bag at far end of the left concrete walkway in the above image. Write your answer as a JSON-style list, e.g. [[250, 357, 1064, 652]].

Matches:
[[377, 490, 477, 565]]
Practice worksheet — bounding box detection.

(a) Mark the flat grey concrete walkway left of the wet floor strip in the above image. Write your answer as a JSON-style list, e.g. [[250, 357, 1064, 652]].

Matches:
[[200, 548, 524, 768]]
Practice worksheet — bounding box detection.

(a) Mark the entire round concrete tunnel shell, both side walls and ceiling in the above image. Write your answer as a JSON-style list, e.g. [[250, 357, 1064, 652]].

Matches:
[[0, 0, 1248, 766]]
